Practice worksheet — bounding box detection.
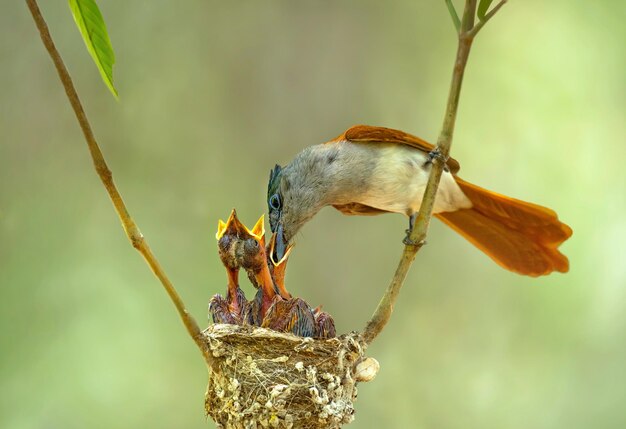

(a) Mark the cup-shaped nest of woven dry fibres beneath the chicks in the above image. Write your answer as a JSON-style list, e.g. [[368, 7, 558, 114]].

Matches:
[[204, 324, 378, 429]]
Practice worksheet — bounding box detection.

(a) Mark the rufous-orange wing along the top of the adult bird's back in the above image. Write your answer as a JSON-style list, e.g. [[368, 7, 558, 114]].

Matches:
[[329, 125, 461, 174]]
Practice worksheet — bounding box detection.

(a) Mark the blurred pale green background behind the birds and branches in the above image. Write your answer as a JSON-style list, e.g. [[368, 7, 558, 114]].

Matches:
[[0, 0, 626, 429]]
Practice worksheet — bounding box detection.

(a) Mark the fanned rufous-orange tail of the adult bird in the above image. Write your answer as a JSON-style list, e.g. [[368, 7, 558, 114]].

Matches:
[[436, 177, 572, 277]]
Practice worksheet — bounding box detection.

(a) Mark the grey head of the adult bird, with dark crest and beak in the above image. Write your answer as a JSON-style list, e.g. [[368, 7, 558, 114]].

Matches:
[[267, 146, 332, 262]]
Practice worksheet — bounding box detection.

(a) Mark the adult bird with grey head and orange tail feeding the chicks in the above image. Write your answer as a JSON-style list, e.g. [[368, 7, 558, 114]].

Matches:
[[267, 125, 572, 277]]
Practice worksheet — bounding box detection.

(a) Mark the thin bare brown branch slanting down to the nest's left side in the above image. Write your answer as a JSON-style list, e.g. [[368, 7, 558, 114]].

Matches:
[[26, 0, 211, 362]]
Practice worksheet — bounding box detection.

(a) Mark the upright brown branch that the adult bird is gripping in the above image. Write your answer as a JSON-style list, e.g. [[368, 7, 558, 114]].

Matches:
[[363, 0, 506, 344]]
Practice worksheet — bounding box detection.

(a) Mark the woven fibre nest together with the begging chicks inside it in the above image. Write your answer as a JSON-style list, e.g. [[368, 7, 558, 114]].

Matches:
[[204, 210, 379, 428]]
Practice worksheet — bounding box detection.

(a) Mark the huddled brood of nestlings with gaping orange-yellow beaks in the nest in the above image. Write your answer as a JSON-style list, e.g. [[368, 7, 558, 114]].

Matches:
[[209, 210, 336, 338]]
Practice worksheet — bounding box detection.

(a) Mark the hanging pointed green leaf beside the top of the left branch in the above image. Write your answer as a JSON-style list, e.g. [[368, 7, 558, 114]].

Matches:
[[69, 0, 117, 99]]
